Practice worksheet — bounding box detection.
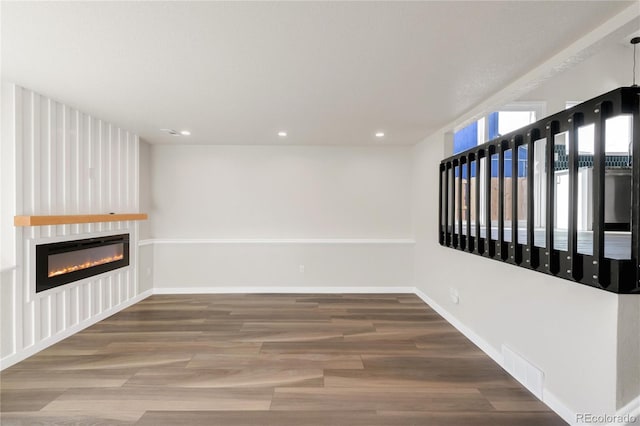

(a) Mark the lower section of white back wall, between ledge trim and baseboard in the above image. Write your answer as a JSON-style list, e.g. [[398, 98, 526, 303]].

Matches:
[[153, 240, 413, 289]]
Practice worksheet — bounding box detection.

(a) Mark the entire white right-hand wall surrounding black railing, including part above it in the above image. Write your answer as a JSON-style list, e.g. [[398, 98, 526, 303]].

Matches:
[[413, 40, 640, 423]]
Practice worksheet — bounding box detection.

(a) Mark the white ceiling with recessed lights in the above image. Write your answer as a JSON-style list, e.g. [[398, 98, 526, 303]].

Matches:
[[1, 1, 634, 144]]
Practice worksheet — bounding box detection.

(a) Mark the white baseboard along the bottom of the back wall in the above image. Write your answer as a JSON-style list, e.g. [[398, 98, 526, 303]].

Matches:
[[153, 285, 415, 294]]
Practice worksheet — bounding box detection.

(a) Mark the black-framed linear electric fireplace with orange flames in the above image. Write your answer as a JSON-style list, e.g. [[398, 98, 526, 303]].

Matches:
[[36, 234, 129, 293]]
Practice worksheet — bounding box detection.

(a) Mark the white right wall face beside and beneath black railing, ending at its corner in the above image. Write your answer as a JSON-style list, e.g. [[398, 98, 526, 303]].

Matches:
[[414, 135, 618, 420]]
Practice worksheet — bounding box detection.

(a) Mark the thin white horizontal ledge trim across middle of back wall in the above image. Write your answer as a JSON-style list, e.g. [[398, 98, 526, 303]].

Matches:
[[138, 238, 416, 246]]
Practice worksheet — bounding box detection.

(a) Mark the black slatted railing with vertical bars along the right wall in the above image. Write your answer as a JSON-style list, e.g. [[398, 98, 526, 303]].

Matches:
[[438, 87, 640, 294]]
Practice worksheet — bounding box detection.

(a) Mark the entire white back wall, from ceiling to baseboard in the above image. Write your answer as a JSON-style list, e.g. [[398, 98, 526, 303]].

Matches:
[[151, 145, 413, 288]]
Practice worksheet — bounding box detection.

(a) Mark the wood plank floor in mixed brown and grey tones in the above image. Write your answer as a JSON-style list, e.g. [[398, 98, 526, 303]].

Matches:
[[0, 294, 566, 426]]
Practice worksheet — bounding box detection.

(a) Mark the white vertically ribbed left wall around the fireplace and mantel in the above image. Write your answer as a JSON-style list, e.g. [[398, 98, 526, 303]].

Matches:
[[0, 82, 146, 368]]
